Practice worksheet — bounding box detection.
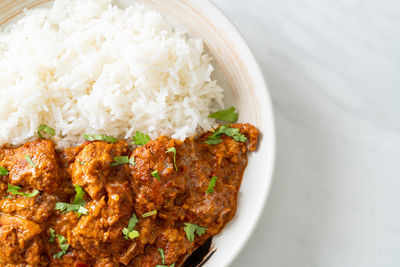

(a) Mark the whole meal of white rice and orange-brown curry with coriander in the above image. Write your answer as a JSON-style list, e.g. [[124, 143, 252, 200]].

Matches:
[[0, 0, 258, 267]]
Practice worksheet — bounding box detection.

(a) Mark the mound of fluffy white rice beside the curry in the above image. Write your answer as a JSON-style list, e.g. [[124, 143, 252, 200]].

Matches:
[[0, 0, 223, 147]]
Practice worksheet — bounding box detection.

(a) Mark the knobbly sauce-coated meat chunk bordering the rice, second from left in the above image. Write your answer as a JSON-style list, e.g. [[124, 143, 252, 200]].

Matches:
[[70, 141, 128, 200]]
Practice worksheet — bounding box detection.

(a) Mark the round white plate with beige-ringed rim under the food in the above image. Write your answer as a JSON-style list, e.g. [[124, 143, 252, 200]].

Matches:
[[0, 0, 275, 267]]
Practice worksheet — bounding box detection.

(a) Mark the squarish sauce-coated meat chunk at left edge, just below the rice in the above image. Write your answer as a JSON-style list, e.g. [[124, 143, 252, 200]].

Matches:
[[0, 139, 60, 192]]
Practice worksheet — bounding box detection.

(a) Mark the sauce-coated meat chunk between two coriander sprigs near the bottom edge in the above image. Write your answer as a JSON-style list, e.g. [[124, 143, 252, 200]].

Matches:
[[68, 182, 133, 262]]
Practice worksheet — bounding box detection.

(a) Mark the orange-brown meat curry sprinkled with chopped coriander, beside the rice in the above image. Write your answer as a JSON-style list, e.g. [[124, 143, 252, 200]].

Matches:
[[0, 123, 258, 267]]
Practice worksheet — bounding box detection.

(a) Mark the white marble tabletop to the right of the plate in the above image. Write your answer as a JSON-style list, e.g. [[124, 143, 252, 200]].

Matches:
[[209, 0, 400, 267]]
